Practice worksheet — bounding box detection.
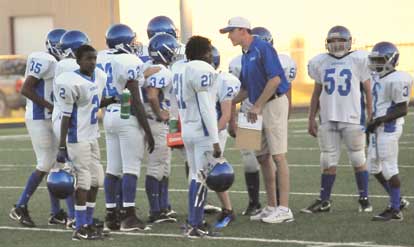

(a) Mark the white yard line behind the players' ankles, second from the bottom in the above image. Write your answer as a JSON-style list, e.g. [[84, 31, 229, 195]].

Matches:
[[0, 186, 414, 199]]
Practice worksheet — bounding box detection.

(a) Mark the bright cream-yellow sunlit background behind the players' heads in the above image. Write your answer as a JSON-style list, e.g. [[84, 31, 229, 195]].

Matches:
[[120, 0, 414, 104]]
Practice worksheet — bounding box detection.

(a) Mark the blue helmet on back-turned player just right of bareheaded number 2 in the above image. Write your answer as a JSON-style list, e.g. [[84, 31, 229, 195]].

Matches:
[[105, 24, 138, 53]]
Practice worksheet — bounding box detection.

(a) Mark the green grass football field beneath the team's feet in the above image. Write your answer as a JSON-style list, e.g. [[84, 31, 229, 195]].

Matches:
[[0, 114, 414, 247]]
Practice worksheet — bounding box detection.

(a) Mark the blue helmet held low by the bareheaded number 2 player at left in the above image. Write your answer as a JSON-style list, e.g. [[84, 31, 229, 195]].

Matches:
[[47, 169, 75, 199]]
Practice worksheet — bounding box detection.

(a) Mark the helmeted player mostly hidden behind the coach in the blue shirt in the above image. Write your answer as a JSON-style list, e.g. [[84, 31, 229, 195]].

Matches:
[[229, 27, 297, 216]]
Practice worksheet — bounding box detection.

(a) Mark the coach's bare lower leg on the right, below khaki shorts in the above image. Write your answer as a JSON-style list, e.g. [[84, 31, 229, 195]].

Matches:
[[272, 154, 290, 208]]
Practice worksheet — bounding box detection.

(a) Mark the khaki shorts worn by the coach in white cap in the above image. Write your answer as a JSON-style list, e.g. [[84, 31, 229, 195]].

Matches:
[[256, 95, 289, 156]]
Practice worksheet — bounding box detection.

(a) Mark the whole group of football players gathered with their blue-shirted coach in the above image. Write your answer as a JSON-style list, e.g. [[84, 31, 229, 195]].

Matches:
[[9, 16, 412, 240]]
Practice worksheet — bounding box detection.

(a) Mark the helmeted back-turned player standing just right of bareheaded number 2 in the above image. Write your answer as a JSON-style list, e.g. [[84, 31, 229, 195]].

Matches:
[[104, 24, 154, 231]]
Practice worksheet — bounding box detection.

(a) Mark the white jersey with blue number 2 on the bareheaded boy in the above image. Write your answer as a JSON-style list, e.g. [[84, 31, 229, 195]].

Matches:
[[55, 68, 106, 143]]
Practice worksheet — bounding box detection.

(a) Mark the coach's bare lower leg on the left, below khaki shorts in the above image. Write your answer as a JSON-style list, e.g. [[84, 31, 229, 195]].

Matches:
[[257, 154, 276, 207]]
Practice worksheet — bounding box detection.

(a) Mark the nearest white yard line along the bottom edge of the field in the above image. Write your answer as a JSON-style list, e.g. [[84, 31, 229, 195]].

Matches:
[[0, 226, 406, 247]]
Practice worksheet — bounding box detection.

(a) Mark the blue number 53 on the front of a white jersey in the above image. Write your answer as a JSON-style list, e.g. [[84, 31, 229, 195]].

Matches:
[[323, 68, 352, 96]]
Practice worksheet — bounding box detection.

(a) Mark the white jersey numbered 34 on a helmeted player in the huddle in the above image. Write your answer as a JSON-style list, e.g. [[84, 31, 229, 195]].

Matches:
[[142, 64, 173, 119]]
